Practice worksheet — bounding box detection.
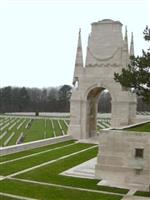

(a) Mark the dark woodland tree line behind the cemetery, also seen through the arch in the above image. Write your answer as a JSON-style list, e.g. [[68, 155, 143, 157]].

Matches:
[[0, 85, 150, 113]]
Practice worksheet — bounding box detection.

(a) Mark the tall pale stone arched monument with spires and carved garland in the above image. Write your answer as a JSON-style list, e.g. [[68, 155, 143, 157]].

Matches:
[[68, 19, 136, 139]]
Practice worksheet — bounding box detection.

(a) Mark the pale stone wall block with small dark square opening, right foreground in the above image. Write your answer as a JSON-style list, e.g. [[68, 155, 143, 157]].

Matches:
[[95, 130, 150, 190]]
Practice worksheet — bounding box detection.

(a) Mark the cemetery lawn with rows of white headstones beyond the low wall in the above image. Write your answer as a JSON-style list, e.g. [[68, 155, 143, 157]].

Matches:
[[0, 117, 110, 146]]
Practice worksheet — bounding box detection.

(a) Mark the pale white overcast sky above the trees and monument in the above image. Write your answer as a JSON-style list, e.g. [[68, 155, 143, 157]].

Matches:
[[0, 0, 150, 88]]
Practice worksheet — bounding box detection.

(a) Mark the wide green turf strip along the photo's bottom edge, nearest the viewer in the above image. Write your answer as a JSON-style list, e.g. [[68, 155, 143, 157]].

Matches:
[[0, 180, 122, 200]]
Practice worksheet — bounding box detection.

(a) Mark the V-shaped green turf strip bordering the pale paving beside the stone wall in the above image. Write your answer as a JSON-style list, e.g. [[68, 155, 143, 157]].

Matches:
[[17, 148, 128, 194]]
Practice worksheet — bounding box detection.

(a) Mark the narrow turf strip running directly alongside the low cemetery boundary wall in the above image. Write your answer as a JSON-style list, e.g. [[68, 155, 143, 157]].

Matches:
[[0, 140, 75, 162]]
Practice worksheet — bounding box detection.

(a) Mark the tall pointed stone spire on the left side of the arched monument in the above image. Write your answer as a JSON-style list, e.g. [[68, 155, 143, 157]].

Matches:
[[73, 29, 83, 85]]
